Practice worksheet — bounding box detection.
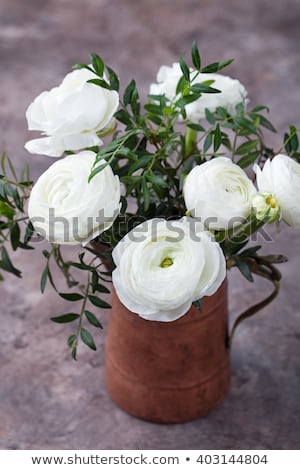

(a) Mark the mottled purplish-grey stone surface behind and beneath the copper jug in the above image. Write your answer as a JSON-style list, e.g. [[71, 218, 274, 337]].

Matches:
[[0, 0, 300, 449]]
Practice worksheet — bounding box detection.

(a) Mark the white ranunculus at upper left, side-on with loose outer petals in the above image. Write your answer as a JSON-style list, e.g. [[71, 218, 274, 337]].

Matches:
[[25, 69, 119, 157]]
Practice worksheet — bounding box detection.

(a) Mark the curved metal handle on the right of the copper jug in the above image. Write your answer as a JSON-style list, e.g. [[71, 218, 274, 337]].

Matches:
[[227, 256, 281, 348]]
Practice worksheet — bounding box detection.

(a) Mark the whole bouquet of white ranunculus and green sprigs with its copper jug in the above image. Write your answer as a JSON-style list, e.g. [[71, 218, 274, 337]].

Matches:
[[0, 43, 300, 421]]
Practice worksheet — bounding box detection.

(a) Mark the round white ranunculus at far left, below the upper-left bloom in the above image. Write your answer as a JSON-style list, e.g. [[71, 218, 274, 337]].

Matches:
[[28, 151, 120, 245]]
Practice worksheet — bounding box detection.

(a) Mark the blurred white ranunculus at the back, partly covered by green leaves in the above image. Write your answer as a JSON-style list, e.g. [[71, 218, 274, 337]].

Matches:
[[150, 63, 247, 123]]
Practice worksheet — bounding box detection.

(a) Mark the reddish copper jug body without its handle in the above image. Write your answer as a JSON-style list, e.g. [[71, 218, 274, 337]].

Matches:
[[105, 281, 230, 423]]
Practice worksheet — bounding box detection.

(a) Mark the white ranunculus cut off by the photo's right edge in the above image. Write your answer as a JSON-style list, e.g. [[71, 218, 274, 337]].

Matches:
[[254, 154, 300, 228]]
